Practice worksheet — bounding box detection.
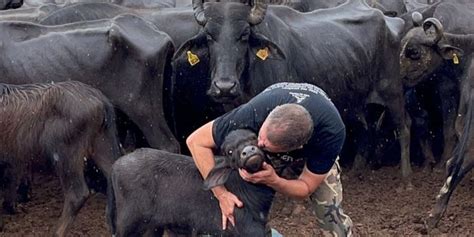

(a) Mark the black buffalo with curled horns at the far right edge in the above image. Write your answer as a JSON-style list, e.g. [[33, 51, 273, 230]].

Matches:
[[400, 0, 474, 166]]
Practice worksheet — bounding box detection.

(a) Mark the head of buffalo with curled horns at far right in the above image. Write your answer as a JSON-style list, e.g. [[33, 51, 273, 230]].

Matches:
[[400, 13, 464, 86]]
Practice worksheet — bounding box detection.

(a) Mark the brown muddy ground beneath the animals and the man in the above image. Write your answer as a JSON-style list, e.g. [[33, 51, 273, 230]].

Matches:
[[0, 167, 474, 236]]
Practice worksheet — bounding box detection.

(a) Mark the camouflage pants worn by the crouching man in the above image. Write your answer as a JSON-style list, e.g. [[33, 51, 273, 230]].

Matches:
[[310, 160, 352, 236]]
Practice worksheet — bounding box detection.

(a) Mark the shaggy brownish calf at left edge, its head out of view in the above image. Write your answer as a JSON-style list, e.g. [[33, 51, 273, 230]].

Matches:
[[0, 81, 120, 236]]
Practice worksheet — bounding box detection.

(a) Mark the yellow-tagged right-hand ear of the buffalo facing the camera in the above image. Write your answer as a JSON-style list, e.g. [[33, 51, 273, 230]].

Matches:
[[249, 32, 286, 60]]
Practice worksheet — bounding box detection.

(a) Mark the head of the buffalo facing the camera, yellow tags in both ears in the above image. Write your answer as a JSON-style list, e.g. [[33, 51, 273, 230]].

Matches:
[[174, 0, 284, 103]]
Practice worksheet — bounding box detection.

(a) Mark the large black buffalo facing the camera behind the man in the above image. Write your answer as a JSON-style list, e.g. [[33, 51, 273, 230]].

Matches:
[[173, 1, 410, 182]]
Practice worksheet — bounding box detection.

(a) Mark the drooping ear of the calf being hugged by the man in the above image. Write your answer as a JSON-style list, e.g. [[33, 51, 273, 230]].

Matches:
[[204, 157, 232, 190]]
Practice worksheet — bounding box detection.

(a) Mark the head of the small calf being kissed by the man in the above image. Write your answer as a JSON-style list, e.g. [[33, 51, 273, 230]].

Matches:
[[204, 129, 265, 189]]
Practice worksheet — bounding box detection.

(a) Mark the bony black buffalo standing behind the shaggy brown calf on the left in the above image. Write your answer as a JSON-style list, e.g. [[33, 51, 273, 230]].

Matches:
[[0, 15, 179, 151]]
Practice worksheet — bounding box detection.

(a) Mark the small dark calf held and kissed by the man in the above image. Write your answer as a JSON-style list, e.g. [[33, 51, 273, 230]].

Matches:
[[107, 130, 274, 236]]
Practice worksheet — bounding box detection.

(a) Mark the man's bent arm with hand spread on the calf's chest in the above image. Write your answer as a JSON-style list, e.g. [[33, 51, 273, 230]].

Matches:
[[186, 121, 243, 230]]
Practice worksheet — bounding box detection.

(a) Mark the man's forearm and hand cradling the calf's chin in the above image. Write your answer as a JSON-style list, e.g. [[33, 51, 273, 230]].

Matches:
[[239, 163, 326, 199]]
